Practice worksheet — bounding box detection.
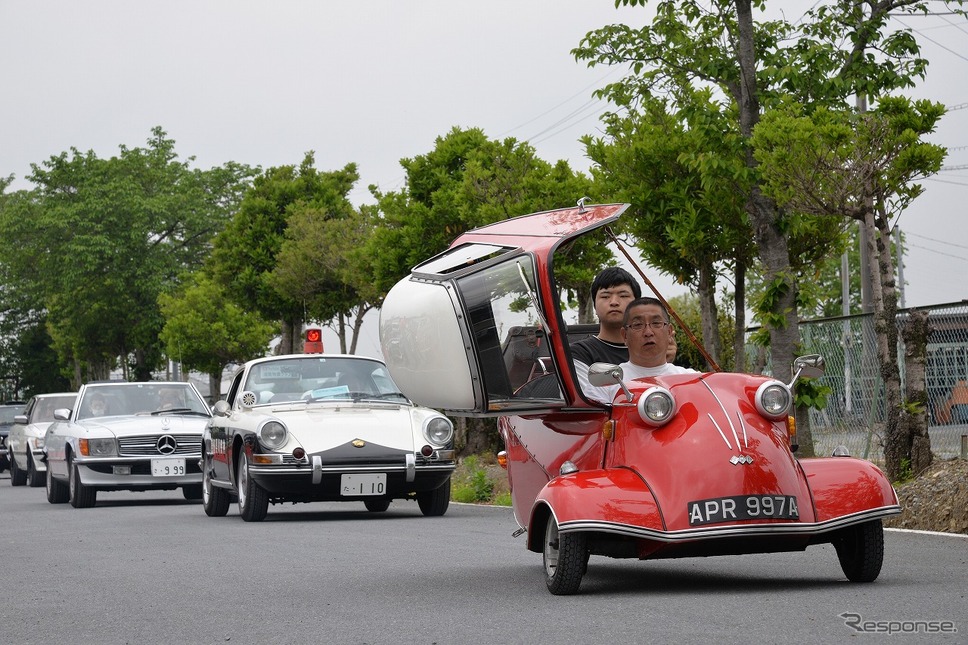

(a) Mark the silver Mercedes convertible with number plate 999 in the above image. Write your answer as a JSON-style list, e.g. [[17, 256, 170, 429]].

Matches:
[[44, 381, 212, 508]]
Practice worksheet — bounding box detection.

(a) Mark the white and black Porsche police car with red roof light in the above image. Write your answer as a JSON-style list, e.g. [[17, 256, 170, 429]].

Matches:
[[202, 354, 456, 522]]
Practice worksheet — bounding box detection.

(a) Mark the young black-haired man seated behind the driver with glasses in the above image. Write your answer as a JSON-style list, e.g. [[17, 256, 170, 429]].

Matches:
[[571, 267, 642, 393]]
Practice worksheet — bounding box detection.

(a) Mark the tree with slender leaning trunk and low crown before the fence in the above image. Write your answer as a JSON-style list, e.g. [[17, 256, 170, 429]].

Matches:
[[754, 97, 945, 479]]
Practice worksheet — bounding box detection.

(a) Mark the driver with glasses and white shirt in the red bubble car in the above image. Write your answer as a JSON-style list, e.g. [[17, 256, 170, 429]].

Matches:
[[584, 297, 696, 403]]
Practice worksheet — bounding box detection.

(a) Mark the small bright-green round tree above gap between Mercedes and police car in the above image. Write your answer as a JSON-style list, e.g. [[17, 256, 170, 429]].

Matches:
[[158, 271, 275, 400]]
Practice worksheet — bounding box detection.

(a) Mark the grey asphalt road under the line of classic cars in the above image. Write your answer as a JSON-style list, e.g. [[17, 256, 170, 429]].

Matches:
[[0, 473, 968, 645]]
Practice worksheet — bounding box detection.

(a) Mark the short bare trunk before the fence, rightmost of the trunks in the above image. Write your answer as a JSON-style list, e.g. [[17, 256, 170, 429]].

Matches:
[[898, 311, 931, 476]]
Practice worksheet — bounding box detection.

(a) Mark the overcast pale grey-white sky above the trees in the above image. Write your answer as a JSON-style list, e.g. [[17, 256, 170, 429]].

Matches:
[[0, 0, 968, 354]]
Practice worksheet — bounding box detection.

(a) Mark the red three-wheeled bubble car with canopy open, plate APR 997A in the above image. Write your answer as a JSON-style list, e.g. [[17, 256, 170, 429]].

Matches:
[[380, 203, 900, 594]]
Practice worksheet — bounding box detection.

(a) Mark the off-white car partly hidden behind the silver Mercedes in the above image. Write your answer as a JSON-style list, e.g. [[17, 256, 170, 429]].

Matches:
[[7, 392, 77, 488]]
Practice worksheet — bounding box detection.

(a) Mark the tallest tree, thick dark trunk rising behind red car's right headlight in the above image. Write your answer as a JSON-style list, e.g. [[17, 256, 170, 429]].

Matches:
[[574, 0, 963, 462]]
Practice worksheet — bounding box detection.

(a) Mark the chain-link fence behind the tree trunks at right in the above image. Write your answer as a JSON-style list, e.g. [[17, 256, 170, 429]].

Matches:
[[764, 301, 968, 463]]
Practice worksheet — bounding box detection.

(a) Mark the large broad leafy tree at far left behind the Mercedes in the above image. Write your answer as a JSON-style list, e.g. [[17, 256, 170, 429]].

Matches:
[[0, 128, 251, 386]]
